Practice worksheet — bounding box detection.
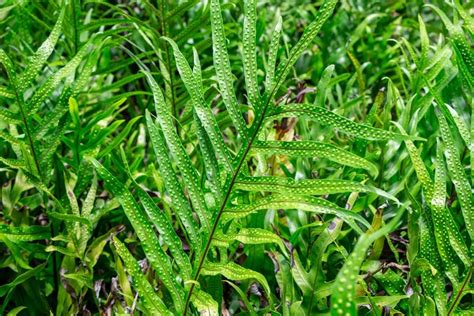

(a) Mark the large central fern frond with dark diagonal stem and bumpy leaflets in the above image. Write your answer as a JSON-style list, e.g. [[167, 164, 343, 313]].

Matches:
[[94, 0, 422, 314]]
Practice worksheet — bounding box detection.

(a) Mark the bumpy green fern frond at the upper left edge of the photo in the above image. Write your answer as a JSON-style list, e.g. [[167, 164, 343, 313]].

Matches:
[[0, 9, 100, 183]]
